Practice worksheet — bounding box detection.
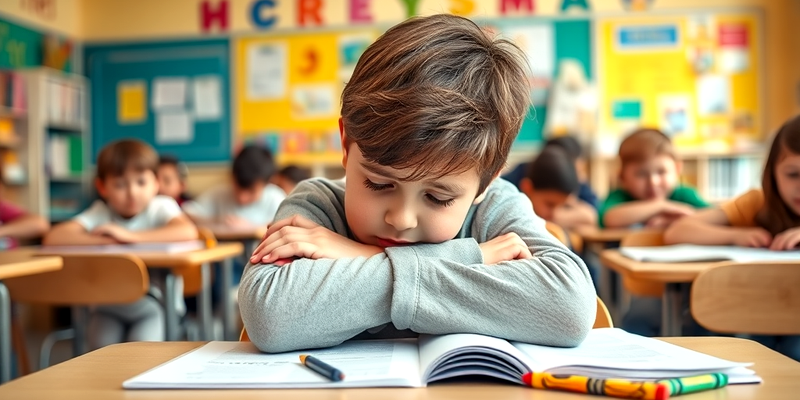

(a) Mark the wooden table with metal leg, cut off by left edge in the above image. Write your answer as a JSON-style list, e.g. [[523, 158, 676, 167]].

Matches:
[[0, 250, 63, 384]]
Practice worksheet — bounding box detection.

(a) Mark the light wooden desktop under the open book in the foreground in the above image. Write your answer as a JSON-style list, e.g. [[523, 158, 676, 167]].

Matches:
[[0, 337, 800, 400]]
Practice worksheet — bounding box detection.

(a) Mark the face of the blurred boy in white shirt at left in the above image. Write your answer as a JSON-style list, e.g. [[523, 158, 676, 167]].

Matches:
[[95, 169, 158, 218]]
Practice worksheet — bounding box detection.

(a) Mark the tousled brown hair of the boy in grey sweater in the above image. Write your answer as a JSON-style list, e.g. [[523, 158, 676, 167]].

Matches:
[[342, 14, 530, 196]]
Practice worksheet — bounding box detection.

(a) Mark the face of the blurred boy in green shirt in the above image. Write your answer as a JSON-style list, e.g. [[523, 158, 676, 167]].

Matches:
[[621, 154, 678, 200]]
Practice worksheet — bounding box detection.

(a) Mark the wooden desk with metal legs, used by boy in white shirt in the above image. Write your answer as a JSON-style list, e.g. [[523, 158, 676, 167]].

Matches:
[[38, 243, 242, 340]]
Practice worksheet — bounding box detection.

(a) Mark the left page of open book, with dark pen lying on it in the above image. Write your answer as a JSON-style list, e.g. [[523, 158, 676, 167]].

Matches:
[[122, 339, 422, 389]]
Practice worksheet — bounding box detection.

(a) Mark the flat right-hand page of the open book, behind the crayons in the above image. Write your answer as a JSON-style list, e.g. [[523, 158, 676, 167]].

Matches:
[[514, 328, 750, 379]]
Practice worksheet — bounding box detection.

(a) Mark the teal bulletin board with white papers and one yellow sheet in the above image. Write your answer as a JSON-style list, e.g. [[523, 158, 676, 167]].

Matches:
[[84, 40, 231, 162]]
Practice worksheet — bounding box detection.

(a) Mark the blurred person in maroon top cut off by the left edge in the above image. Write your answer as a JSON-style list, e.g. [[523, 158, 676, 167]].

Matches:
[[0, 157, 50, 251]]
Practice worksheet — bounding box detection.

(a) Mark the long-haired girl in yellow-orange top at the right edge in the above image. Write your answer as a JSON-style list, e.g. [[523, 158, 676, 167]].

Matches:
[[664, 116, 800, 361]]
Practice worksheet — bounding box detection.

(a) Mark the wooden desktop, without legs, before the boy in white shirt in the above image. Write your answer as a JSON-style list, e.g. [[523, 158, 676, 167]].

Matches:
[[39, 243, 244, 268]]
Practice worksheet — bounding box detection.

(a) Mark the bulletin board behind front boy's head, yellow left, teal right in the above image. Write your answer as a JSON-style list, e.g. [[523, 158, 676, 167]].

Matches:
[[233, 17, 593, 159]]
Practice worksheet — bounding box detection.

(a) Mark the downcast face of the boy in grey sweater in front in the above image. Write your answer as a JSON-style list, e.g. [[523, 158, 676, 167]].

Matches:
[[343, 144, 479, 247]]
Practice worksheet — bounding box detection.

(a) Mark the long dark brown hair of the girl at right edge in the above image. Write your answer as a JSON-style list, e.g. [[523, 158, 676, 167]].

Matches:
[[756, 116, 800, 235]]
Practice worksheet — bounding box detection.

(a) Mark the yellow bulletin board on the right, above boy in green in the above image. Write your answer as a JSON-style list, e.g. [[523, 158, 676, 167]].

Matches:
[[596, 11, 764, 151]]
